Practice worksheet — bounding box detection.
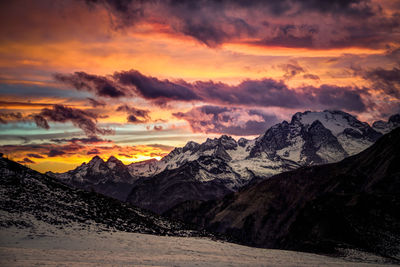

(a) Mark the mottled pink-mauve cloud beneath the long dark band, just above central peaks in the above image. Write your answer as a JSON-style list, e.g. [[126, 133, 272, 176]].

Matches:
[[173, 105, 278, 136]]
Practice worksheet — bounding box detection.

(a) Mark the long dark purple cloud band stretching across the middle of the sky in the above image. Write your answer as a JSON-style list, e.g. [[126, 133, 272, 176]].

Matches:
[[56, 69, 367, 111]]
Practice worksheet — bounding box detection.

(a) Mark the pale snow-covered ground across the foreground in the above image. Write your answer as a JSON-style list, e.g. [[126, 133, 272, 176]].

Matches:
[[0, 223, 396, 266]]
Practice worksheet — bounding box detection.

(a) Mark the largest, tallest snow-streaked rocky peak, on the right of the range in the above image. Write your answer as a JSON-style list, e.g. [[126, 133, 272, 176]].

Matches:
[[250, 110, 382, 165]]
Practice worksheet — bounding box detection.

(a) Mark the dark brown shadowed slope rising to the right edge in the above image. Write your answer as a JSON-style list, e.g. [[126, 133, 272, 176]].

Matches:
[[167, 128, 400, 260]]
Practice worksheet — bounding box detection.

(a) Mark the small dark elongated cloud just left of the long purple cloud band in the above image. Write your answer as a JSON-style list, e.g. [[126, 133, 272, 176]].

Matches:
[[54, 72, 125, 98]]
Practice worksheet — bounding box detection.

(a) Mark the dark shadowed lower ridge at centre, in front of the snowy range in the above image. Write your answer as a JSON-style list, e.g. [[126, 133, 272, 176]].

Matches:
[[127, 156, 238, 213]]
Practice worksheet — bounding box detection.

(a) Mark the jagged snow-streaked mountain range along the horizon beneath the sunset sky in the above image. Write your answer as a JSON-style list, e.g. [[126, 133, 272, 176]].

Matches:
[[48, 110, 400, 213]]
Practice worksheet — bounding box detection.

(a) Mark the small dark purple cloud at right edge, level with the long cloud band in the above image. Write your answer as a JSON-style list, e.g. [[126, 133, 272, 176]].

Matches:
[[362, 67, 400, 99]]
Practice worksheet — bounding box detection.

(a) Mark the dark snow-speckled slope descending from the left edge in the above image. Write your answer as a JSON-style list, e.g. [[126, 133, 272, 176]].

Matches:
[[0, 158, 205, 236]]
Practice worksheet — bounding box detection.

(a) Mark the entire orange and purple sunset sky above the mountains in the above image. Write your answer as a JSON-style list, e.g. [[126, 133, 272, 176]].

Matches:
[[0, 0, 400, 172]]
